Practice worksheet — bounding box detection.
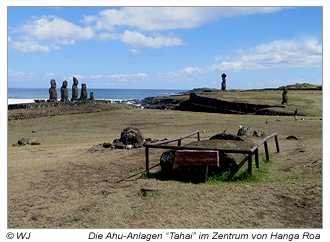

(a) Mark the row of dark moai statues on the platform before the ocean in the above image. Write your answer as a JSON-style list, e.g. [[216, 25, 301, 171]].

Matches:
[[48, 77, 95, 102]]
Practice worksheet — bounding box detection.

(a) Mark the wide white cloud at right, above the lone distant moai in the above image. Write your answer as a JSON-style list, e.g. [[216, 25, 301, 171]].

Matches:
[[210, 38, 322, 71]]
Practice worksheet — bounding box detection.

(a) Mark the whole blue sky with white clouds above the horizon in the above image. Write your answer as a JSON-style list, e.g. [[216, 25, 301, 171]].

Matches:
[[8, 7, 322, 89]]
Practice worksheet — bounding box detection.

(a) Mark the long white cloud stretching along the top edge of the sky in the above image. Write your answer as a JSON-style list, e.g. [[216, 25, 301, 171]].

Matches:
[[84, 7, 283, 31]]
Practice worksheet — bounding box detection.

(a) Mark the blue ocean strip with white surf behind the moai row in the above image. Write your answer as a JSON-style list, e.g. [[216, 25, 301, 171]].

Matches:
[[8, 88, 187, 104]]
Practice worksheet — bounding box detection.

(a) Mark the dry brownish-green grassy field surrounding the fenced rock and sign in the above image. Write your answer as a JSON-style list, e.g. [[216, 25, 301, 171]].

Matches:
[[8, 91, 322, 228]]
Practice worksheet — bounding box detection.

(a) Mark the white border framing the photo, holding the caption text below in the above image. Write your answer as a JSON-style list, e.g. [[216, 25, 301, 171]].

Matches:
[[0, 0, 330, 241]]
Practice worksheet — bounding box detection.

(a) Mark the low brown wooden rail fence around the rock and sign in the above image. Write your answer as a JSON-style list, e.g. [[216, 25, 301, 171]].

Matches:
[[145, 130, 280, 175]]
